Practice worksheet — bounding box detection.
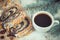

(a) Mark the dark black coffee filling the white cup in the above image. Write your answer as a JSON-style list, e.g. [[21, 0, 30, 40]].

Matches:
[[34, 13, 52, 27]]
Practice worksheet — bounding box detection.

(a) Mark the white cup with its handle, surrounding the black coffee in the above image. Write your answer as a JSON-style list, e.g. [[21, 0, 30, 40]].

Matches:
[[32, 11, 59, 32]]
